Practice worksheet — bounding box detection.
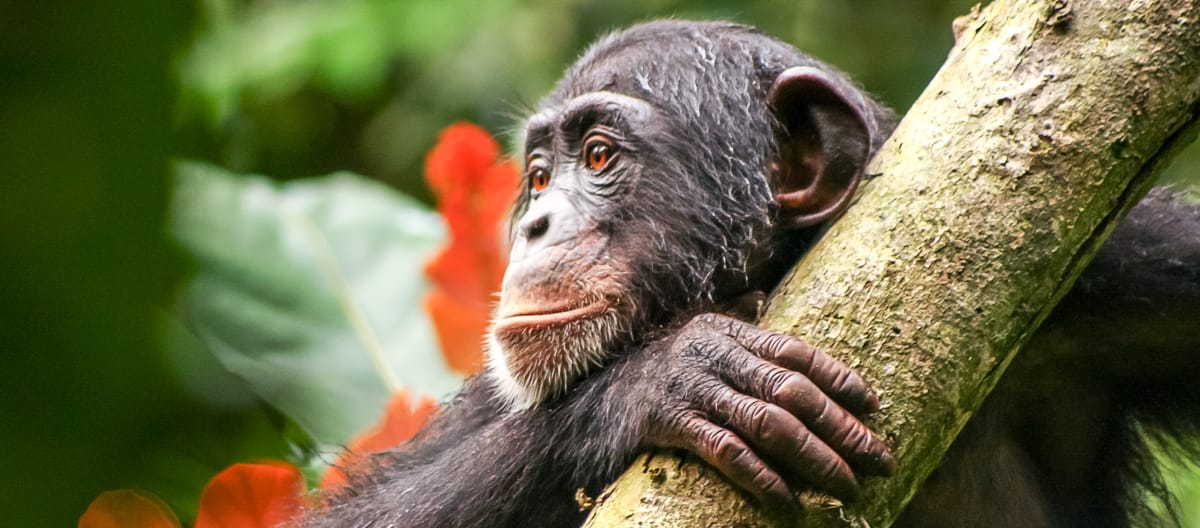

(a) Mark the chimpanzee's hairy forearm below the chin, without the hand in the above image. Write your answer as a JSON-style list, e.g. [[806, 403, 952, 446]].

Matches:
[[304, 377, 595, 527]]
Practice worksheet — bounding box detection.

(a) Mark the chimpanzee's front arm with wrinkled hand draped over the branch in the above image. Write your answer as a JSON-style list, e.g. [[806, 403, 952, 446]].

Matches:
[[308, 314, 894, 527]]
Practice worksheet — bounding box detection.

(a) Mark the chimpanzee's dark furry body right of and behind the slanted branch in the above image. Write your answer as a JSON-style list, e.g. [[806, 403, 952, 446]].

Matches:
[[900, 188, 1200, 528]]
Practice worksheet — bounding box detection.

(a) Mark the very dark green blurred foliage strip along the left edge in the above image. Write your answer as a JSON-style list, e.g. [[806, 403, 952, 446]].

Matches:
[[0, 0, 189, 527]]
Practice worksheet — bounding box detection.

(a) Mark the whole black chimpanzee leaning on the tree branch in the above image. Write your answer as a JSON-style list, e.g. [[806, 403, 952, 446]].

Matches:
[[305, 20, 1200, 527]]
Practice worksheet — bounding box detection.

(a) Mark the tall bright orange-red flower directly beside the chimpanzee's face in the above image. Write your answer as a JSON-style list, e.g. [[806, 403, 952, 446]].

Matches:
[[425, 122, 517, 374]]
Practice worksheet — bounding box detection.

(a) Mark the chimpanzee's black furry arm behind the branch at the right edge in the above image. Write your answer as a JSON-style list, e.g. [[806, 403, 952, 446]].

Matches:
[[1026, 188, 1200, 380]]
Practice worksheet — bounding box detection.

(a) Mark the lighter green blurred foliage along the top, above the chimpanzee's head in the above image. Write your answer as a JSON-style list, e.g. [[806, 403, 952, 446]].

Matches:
[[179, 0, 1200, 200]]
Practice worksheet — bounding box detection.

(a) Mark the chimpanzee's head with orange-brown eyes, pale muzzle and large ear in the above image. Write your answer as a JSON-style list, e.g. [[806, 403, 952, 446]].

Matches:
[[488, 20, 888, 408]]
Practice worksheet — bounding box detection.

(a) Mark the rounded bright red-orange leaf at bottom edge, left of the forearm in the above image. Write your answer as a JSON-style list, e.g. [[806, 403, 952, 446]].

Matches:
[[196, 462, 305, 528]]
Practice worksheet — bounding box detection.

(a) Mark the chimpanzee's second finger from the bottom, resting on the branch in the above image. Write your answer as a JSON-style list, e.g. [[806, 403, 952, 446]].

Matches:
[[713, 388, 859, 499]]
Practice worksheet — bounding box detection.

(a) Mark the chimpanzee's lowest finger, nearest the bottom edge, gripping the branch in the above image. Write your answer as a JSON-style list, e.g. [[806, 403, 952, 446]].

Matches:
[[682, 416, 798, 511]]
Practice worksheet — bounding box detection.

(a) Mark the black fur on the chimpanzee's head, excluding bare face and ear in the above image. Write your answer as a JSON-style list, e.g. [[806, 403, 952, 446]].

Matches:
[[515, 22, 895, 323]]
